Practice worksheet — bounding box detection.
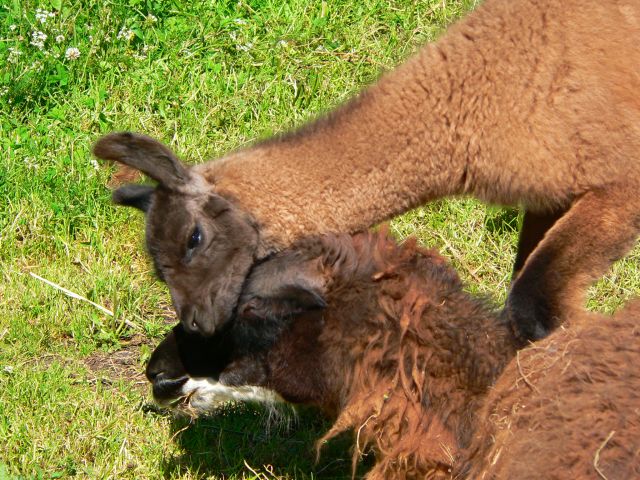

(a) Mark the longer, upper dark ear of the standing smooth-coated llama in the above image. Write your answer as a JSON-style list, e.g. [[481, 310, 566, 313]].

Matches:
[[93, 132, 189, 190]]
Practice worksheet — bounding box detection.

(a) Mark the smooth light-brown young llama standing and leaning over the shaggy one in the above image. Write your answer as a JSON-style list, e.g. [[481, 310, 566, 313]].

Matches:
[[94, 0, 640, 340]]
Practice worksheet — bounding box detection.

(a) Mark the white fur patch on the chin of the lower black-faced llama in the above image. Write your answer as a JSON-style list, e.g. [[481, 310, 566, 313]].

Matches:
[[176, 378, 284, 415]]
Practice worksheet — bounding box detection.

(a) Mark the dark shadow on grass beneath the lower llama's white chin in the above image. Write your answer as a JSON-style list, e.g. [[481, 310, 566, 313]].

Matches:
[[163, 405, 373, 480]]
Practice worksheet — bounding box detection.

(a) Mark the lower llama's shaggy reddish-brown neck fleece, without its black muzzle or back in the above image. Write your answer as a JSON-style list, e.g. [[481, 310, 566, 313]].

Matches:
[[250, 234, 517, 479]]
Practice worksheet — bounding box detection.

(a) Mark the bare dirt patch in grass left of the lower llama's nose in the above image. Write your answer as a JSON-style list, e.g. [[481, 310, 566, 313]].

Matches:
[[84, 335, 152, 392]]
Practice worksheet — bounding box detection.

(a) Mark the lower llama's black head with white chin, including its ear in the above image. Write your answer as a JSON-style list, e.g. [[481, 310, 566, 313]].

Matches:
[[147, 248, 325, 410]]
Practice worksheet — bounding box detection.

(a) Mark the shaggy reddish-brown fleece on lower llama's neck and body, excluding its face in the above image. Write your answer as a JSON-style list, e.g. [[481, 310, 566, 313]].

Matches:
[[252, 234, 640, 480]]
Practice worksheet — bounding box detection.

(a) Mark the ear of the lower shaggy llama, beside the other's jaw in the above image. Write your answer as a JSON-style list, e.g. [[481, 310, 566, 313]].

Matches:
[[238, 255, 327, 318]]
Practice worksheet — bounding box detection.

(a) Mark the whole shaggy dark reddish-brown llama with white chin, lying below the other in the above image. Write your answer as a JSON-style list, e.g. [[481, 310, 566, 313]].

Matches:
[[147, 234, 640, 480]]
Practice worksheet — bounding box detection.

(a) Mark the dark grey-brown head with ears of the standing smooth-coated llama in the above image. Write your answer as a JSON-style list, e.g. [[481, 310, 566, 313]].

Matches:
[[93, 133, 258, 336]]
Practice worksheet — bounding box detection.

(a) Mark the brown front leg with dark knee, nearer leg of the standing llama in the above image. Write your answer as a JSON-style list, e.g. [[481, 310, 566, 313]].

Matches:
[[506, 185, 640, 342]]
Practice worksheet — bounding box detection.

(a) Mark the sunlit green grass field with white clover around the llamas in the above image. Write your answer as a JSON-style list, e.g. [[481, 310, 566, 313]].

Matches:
[[0, 0, 640, 479]]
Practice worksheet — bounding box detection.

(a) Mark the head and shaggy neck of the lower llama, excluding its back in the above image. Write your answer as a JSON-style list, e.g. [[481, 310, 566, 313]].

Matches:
[[147, 234, 516, 479]]
